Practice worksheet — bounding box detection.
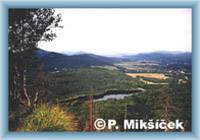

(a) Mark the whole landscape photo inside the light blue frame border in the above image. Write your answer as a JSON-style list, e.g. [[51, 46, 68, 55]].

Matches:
[[8, 8, 192, 132]]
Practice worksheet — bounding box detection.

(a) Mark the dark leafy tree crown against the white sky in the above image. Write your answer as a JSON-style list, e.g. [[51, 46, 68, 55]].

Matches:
[[8, 8, 61, 53]]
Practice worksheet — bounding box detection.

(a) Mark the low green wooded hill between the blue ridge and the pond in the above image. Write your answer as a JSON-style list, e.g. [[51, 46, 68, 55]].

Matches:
[[39, 68, 141, 99]]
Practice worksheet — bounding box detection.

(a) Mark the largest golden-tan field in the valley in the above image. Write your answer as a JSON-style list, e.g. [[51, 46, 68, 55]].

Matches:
[[126, 73, 169, 80]]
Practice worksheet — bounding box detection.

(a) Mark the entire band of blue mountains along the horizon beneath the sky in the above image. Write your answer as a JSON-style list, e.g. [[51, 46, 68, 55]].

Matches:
[[35, 49, 192, 70]]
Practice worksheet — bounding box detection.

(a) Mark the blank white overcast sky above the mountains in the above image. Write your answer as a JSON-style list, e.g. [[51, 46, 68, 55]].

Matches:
[[38, 8, 192, 56]]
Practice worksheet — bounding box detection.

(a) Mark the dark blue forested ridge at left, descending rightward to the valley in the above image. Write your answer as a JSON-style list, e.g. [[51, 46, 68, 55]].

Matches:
[[35, 49, 120, 69]]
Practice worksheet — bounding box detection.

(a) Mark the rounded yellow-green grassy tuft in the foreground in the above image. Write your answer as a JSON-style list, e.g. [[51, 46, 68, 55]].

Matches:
[[18, 105, 78, 131]]
